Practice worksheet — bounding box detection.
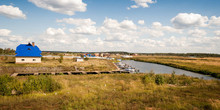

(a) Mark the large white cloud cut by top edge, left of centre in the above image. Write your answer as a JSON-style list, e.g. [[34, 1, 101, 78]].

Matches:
[[28, 0, 87, 15]]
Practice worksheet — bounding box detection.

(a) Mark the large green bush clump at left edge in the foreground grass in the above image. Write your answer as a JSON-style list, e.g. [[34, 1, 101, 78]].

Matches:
[[0, 75, 61, 96]]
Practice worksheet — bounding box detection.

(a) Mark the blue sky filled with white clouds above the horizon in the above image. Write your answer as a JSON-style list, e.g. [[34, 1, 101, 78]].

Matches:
[[0, 0, 220, 54]]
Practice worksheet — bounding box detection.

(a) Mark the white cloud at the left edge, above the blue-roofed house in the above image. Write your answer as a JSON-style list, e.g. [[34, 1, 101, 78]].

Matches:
[[0, 5, 26, 19]]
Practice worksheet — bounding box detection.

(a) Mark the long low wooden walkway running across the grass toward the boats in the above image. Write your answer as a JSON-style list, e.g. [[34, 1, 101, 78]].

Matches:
[[11, 70, 130, 77]]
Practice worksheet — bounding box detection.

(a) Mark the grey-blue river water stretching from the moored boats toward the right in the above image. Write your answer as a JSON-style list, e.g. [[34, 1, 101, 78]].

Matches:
[[122, 60, 216, 80]]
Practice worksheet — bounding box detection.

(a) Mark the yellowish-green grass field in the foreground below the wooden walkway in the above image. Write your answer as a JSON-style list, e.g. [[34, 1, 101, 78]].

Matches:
[[0, 74, 220, 110]]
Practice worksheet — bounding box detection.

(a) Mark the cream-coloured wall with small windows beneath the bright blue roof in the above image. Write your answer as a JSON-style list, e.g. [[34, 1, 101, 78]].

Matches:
[[15, 57, 41, 63]]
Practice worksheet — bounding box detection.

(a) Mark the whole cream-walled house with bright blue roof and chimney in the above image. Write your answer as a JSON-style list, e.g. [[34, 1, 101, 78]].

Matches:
[[15, 42, 42, 63]]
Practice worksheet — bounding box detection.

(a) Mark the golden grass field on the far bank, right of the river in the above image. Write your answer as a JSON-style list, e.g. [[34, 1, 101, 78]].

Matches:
[[132, 56, 220, 78]]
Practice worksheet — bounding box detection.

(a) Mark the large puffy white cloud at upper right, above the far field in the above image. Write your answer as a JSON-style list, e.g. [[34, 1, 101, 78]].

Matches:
[[171, 13, 208, 28]]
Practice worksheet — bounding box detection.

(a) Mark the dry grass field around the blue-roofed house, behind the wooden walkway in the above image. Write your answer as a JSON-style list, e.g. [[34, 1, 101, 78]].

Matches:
[[0, 56, 117, 74]]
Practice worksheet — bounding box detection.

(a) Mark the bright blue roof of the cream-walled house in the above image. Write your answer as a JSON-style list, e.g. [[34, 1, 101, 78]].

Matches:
[[15, 43, 42, 57]]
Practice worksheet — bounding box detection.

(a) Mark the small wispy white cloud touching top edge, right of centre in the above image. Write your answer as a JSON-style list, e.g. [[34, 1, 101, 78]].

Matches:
[[130, 0, 156, 8]]
